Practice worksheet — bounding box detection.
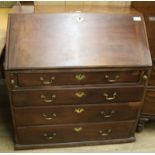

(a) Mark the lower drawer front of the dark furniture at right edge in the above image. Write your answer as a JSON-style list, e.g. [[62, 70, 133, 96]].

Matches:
[[142, 89, 155, 115]]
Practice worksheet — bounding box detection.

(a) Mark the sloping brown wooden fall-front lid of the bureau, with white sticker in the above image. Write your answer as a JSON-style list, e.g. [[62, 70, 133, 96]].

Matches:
[[6, 13, 151, 70]]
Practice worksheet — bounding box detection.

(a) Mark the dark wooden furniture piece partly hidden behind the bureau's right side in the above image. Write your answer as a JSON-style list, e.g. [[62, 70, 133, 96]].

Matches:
[[132, 1, 155, 131]]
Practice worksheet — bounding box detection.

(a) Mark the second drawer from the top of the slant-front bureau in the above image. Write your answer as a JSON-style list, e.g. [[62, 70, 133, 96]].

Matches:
[[12, 86, 144, 106]]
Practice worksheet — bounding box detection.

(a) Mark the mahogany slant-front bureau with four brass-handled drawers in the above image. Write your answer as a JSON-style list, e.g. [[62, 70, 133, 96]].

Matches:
[[5, 12, 152, 149]]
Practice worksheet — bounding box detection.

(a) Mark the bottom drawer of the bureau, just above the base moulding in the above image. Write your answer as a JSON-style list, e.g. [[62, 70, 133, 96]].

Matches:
[[17, 121, 135, 144]]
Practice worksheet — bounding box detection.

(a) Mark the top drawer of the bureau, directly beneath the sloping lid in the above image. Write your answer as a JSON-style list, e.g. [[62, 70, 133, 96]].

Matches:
[[15, 71, 142, 87]]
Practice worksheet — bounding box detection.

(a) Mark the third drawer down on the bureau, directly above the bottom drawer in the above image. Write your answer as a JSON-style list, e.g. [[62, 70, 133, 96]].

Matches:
[[14, 102, 140, 126]]
